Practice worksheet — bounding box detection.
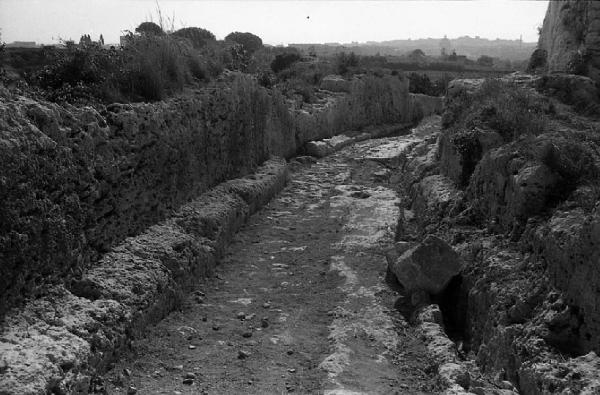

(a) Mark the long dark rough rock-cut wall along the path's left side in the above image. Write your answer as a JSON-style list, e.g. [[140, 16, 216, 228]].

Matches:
[[0, 76, 408, 317]]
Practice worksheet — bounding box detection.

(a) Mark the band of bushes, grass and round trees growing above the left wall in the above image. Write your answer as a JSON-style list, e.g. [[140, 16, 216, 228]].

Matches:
[[2, 15, 422, 106]]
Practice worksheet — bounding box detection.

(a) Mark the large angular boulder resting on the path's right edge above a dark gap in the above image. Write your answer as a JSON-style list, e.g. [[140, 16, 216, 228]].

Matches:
[[389, 235, 460, 295]]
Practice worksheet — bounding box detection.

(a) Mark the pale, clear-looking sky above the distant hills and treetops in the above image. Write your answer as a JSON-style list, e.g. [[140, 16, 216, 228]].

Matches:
[[0, 0, 548, 44]]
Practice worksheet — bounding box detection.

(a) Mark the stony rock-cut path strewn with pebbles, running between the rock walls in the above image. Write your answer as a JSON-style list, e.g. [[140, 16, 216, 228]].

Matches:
[[104, 131, 437, 394]]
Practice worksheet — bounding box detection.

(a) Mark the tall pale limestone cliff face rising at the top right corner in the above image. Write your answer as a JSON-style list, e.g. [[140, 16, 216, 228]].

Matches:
[[539, 0, 600, 81]]
